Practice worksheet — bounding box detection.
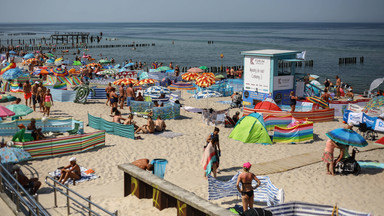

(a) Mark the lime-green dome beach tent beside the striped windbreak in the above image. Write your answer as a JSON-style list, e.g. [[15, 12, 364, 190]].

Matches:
[[229, 113, 272, 144]]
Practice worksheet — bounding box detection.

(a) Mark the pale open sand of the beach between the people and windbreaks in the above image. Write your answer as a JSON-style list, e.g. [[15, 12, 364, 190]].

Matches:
[[2, 86, 384, 215]]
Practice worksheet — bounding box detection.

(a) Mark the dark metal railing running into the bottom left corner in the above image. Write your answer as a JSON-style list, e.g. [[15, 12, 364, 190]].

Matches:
[[0, 163, 50, 216]]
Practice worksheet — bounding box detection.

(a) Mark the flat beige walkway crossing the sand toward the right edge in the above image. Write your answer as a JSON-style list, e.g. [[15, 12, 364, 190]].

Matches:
[[252, 144, 384, 175]]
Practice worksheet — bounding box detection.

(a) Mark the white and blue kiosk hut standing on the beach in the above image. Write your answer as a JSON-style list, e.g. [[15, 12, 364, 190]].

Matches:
[[241, 49, 303, 108]]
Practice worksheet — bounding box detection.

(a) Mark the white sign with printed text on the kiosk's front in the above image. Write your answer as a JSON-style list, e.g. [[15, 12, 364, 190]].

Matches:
[[244, 56, 271, 93]]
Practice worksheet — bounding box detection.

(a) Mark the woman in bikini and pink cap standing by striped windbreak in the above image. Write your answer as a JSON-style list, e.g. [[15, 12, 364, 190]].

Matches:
[[236, 162, 261, 211]]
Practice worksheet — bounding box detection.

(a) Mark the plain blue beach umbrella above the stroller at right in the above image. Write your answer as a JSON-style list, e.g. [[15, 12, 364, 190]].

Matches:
[[325, 128, 368, 147]]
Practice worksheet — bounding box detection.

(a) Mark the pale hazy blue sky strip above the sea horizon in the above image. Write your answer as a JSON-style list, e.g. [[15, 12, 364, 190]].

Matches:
[[0, 0, 384, 23]]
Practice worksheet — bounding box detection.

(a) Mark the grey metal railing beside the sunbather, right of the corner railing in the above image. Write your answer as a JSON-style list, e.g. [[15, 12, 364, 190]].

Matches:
[[45, 176, 117, 216]]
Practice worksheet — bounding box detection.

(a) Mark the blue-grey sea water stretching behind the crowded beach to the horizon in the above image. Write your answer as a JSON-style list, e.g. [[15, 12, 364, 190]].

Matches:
[[0, 23, 384, 93]]
